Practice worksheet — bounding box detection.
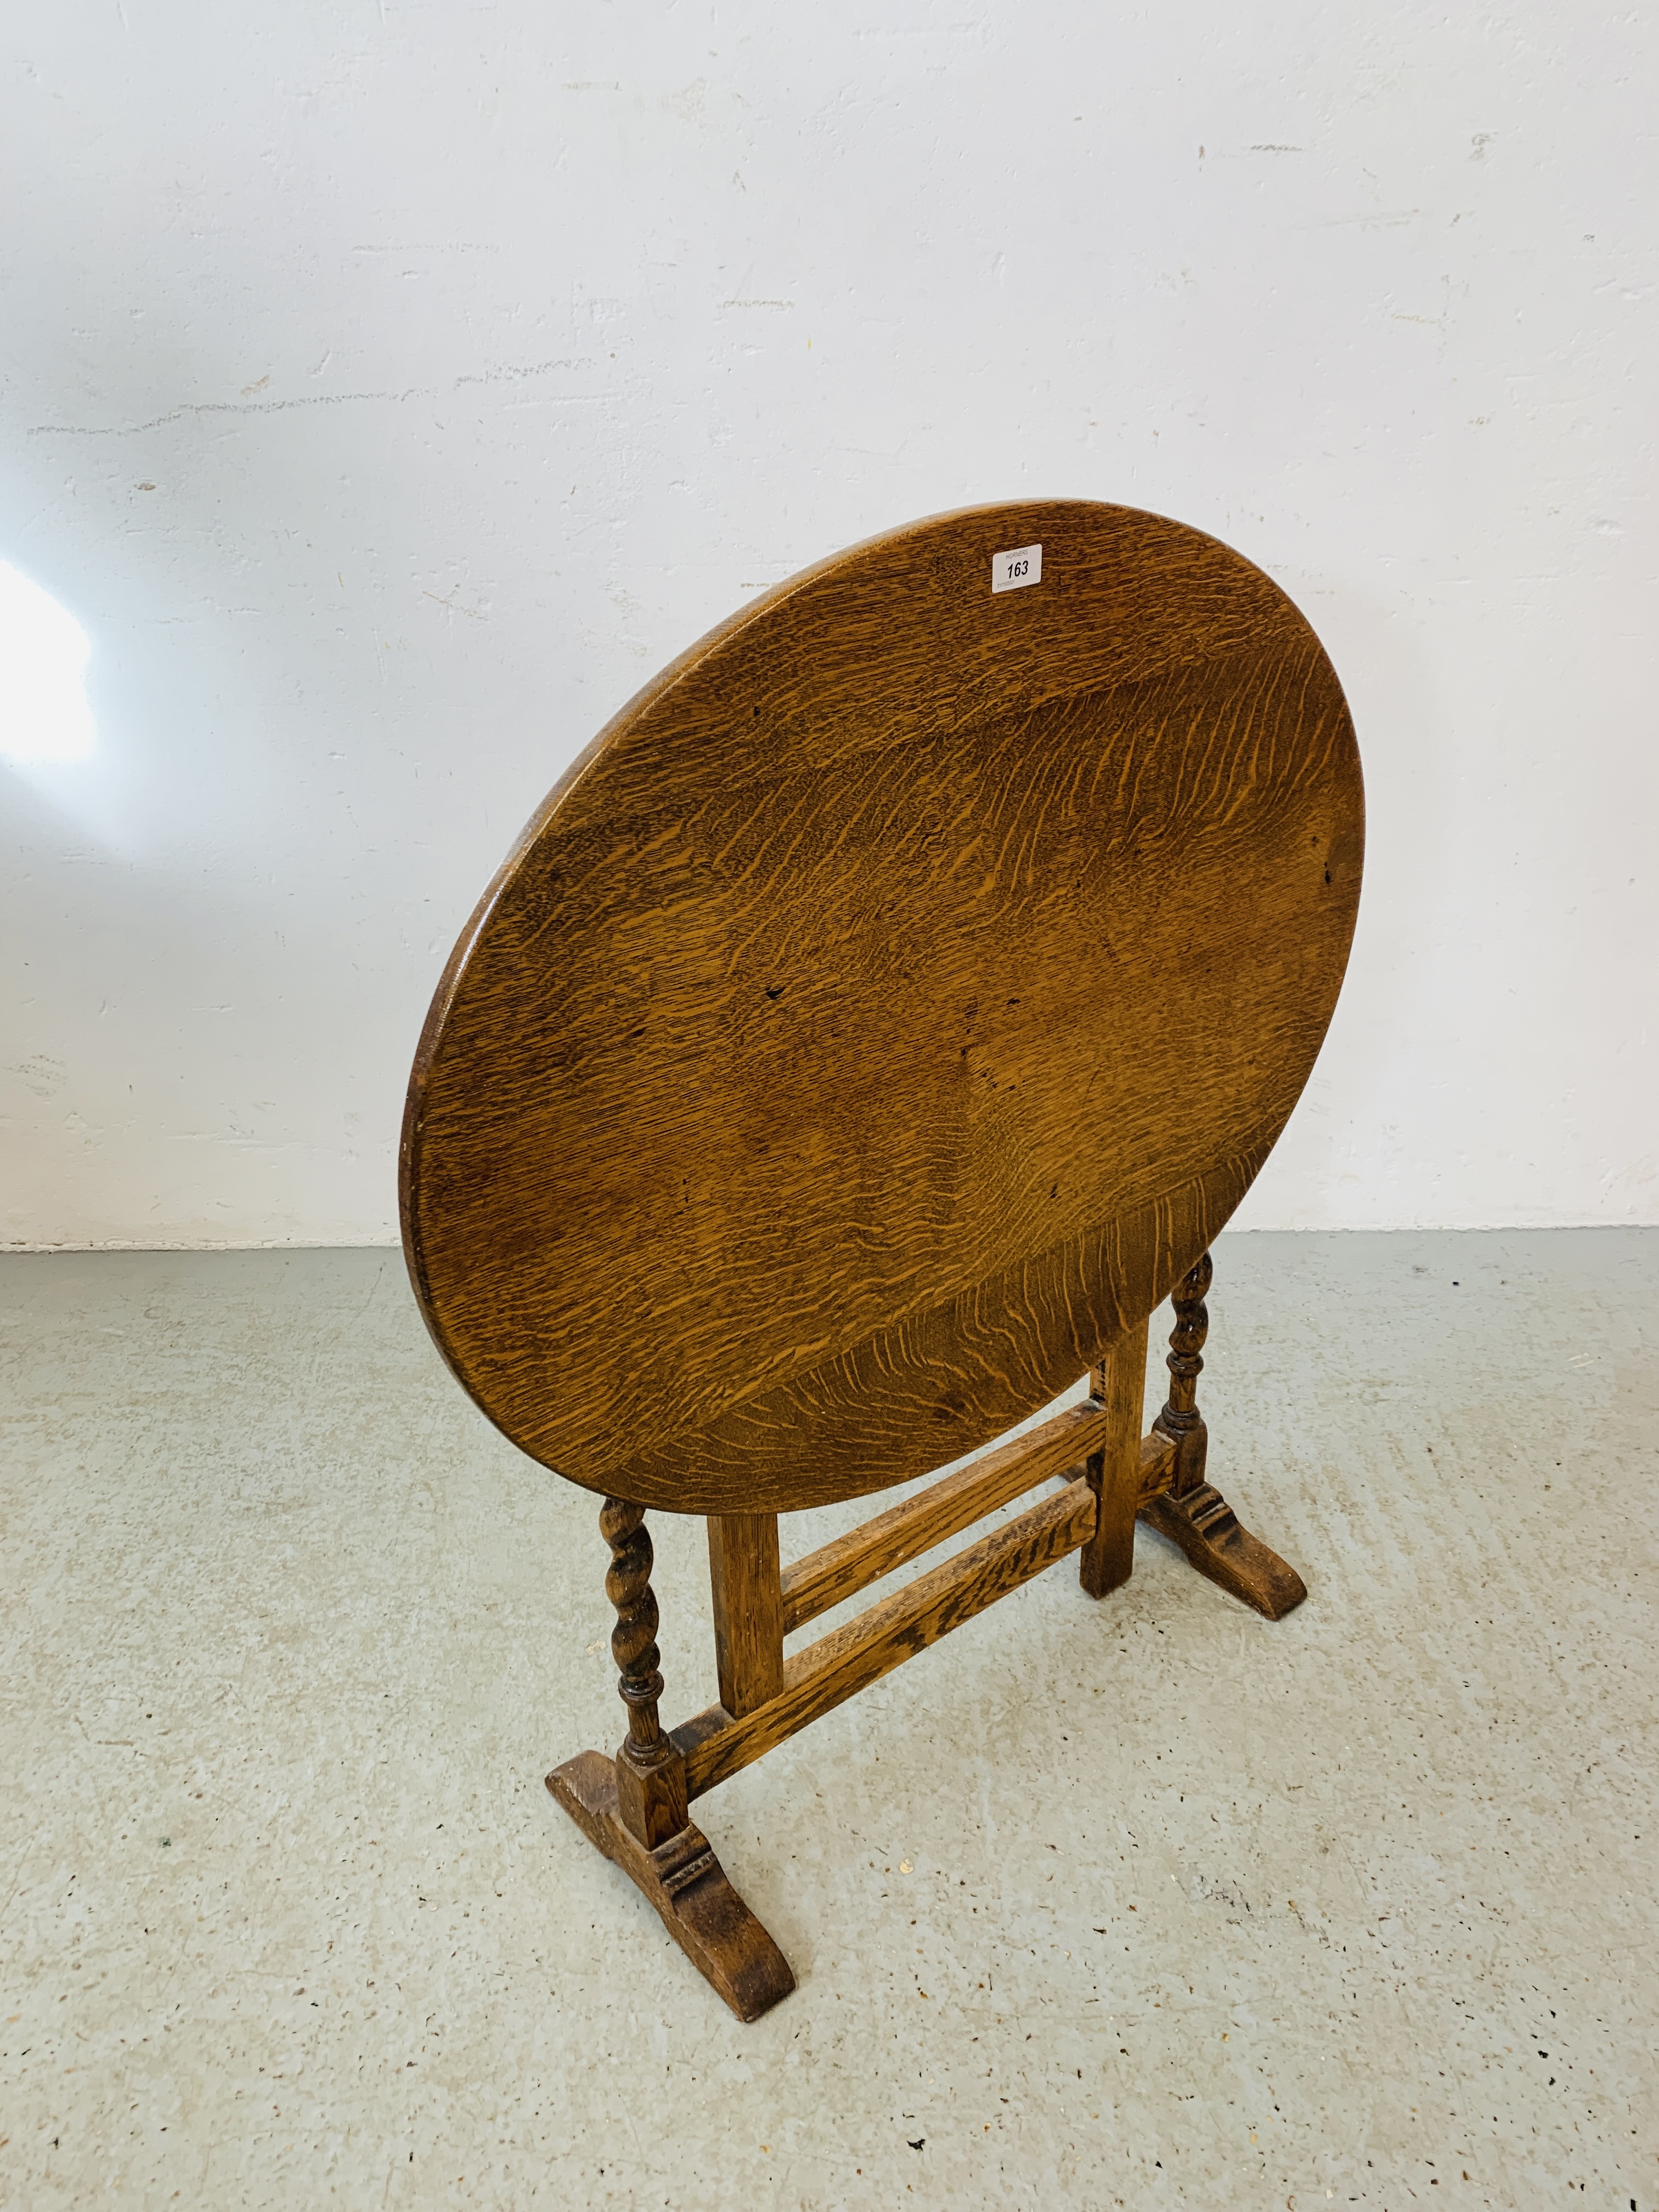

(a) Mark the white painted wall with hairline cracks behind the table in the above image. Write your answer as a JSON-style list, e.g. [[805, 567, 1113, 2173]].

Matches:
[[0, 0, 1659, 1245]]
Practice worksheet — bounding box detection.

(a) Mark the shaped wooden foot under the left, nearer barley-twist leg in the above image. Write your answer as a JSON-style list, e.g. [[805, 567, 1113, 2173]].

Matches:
[[546, 1752, 794, 2019]]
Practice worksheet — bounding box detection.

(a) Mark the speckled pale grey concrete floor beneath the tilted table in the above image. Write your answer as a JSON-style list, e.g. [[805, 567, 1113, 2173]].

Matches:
[[0, 1230, 1659, 2212]]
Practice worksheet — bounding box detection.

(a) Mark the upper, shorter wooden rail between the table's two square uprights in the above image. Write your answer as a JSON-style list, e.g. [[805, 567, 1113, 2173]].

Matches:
[[783, 1400, 1106, 1637]]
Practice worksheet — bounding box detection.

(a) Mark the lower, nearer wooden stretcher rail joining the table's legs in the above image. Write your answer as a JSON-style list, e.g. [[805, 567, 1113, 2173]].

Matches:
[[673, 1480, 1095, 1798]]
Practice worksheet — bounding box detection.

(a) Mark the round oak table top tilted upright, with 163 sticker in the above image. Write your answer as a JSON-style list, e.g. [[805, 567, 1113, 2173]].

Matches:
[[400, 500, 1365, 1513]]
